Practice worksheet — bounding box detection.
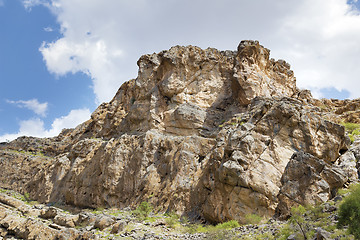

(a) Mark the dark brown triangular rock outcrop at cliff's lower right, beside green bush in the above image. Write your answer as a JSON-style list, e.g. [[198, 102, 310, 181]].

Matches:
[[277, 152, 349, 218]]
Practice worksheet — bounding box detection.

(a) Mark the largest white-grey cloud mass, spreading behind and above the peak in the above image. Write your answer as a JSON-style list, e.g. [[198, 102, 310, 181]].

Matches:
[[24, 0, 360, 102]]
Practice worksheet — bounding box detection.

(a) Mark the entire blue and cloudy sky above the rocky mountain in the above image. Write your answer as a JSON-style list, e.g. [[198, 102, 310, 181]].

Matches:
[[0, 0, 360, 142]]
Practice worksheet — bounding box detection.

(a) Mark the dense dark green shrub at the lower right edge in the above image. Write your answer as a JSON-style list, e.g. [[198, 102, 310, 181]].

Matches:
[[338, 185, 360, 239]]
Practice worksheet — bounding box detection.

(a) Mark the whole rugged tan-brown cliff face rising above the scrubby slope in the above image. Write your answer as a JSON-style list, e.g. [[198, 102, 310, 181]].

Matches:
[[0, 41, 359, 222]]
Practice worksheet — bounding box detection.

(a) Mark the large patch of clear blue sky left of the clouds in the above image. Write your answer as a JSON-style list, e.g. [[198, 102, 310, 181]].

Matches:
[[0, 0, 96, 140]]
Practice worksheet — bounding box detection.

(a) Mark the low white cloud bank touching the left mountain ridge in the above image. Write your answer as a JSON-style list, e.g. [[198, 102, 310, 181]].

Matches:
[[0, 108, 91, 142]]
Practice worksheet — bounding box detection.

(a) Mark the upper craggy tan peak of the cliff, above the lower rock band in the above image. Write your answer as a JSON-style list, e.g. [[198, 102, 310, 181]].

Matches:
[[74, 41, 297, 138]]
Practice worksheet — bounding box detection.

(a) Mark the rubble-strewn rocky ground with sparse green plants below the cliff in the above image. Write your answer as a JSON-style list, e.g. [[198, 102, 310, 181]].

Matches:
[[0, 185, 354, 240]]
